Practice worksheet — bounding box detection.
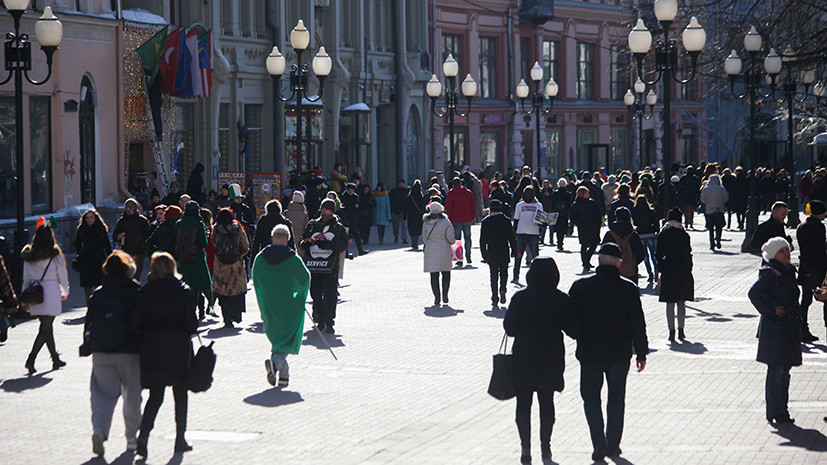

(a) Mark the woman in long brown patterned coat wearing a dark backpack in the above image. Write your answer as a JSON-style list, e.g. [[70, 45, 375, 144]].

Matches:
[[212, 208, 250, 328]]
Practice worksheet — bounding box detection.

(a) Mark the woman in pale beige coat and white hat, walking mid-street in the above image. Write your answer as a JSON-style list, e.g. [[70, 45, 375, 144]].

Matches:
[[422, 201, 455, 306]]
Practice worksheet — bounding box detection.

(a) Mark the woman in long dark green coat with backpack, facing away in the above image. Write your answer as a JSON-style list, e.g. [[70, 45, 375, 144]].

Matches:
[[175, 200, 212, 319]]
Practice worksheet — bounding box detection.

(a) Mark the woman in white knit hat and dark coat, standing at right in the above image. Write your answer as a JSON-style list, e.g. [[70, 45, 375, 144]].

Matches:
[[749, 237, 801, 423]]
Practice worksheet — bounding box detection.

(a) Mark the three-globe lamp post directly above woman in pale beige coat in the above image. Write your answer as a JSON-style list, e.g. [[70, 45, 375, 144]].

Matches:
[[425, 54, 477, 177]]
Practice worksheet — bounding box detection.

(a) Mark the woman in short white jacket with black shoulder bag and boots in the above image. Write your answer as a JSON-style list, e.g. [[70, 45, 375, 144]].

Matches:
[[21, 218, 69, 374]]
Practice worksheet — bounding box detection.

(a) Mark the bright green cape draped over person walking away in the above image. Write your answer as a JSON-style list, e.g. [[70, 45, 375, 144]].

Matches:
[[253, 245, 310, 354]]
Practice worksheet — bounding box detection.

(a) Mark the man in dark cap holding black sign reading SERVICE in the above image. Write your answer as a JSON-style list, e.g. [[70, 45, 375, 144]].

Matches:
[[301, 199, 347, 334]]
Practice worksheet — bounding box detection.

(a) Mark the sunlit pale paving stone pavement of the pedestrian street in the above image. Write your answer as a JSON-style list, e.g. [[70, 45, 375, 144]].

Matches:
[[0, 212, 827, 465]]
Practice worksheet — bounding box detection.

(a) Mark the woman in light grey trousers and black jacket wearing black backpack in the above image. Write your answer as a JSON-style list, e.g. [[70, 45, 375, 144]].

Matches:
[[83, 250, 141, 457]]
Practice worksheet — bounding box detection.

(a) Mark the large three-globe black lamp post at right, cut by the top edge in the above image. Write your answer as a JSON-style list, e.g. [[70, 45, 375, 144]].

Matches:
[[629, 0, 706, 216]]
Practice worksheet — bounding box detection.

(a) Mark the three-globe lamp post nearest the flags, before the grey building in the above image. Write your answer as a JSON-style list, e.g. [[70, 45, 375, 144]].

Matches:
[[266, 19, 333, 173]]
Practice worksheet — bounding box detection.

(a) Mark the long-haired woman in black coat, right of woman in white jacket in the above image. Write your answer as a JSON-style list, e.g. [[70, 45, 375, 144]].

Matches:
[[73, 208, 112, 305]]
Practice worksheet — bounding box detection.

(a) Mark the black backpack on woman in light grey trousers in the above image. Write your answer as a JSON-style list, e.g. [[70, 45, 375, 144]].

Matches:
[[86, 289, 129, 352]]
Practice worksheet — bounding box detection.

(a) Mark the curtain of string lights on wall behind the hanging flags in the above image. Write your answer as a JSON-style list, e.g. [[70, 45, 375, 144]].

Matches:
[[121, 21, 177, 186]]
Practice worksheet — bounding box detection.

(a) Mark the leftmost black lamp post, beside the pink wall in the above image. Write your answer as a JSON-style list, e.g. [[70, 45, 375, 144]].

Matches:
[[0, 0, 63, 286]]
